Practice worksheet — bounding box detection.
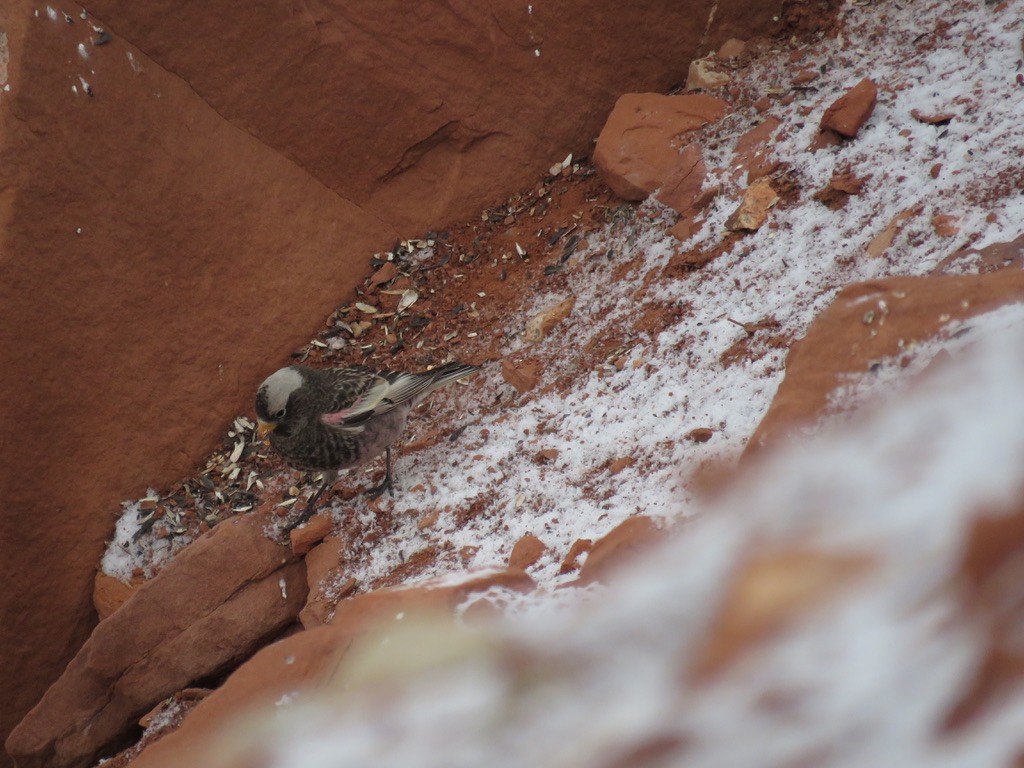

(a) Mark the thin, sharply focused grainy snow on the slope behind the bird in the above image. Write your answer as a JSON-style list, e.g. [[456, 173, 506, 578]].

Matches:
[[104, 2, 1024, 602]]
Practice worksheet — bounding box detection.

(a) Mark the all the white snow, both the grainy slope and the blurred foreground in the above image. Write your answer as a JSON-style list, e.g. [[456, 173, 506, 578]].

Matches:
[[86, 0, 1024, 768]]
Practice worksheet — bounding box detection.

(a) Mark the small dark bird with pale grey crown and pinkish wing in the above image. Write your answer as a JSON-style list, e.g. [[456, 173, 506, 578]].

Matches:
[[256, 362, 480, 527]]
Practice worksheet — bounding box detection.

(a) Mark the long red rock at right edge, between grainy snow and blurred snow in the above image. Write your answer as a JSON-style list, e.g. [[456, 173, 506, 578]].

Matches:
[[743, 269, 1024, 459]]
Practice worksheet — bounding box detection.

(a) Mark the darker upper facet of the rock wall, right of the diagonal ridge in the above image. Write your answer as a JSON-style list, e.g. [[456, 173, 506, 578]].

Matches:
[[77, 0, 781, 233]]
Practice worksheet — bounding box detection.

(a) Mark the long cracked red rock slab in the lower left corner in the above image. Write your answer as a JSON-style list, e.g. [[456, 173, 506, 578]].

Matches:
[[6, 514, 306, 768]]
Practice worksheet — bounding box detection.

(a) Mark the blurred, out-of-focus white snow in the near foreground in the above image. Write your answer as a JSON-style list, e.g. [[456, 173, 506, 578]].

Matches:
[[251, 305, 1024, 768]]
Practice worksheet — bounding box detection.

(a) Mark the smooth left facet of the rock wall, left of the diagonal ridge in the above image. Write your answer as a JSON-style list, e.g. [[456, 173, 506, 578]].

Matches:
[[0, 15, 385, 763]]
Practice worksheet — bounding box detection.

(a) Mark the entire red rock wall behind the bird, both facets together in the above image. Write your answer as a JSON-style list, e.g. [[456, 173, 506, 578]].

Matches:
[[0, 0, 780, 763]]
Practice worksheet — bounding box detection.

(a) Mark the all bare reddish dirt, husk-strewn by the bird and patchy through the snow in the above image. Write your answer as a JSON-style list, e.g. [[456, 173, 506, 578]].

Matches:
[[114, 2, 838, 594]]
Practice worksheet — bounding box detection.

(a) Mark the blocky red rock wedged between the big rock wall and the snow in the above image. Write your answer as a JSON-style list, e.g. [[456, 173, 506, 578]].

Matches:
[[594, 93, 728, 200]]
